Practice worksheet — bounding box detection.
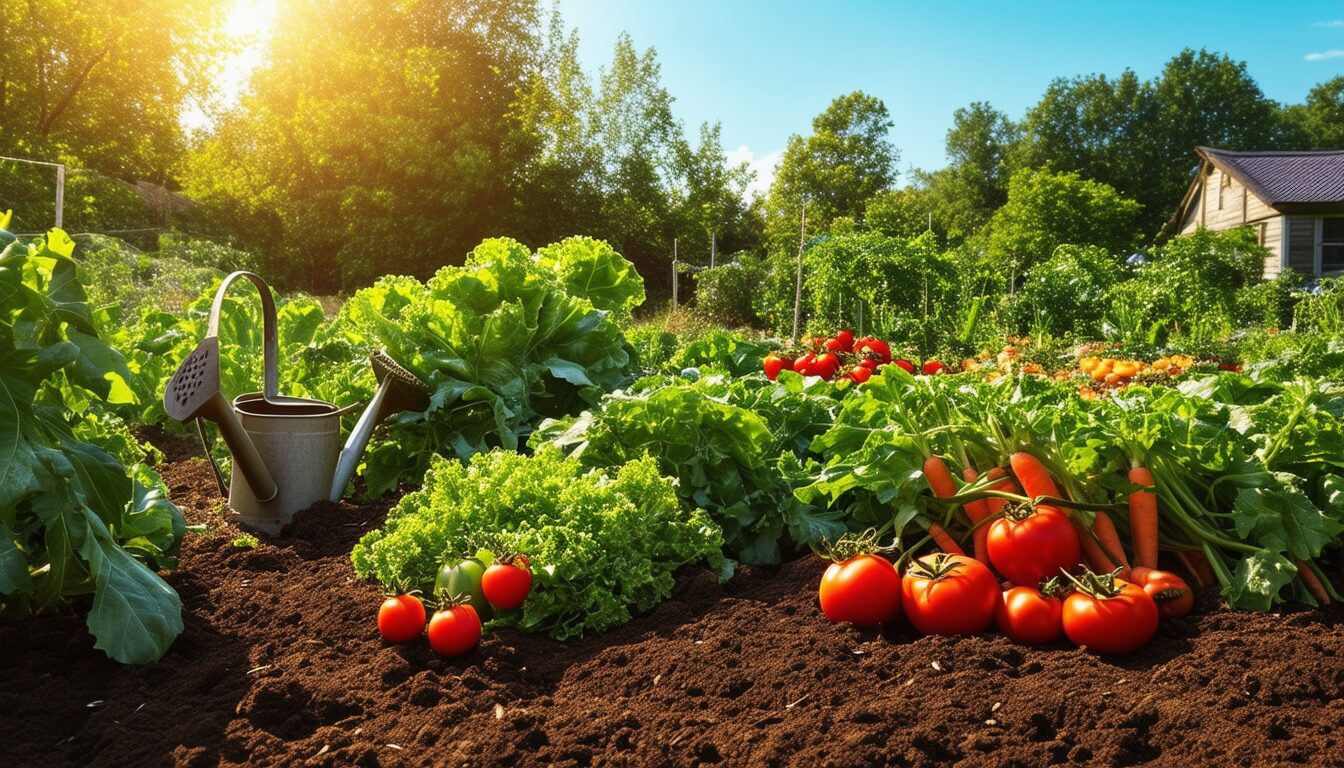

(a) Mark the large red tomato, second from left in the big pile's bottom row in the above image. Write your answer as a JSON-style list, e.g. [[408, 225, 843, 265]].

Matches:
[[900, 553, 999, 635]]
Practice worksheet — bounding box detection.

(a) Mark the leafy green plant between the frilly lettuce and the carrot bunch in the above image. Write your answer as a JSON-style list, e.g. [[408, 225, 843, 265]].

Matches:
[[530, 371, 844, 564]]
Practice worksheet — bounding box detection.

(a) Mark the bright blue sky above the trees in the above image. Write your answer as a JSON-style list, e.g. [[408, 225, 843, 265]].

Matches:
[[559, 0, 1344, 193]]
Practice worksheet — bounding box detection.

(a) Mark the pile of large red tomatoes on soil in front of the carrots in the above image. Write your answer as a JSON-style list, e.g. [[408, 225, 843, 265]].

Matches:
[[820, 452, 1195, 654]]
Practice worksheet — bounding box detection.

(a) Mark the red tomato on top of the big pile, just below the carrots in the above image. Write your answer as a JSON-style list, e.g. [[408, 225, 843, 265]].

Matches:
[[985, 504, 1082, 585]]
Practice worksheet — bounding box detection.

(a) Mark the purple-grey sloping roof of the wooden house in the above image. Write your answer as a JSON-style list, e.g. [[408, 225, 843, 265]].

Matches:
[[1196, 147, 1344, 207]]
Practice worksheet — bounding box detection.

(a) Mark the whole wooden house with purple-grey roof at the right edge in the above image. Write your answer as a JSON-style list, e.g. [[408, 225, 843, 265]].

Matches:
[[1164, 147, 1344, 278]]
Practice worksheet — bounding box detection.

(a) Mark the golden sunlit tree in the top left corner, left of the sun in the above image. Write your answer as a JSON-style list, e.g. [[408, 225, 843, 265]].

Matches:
[[0, 0, 226, 182]]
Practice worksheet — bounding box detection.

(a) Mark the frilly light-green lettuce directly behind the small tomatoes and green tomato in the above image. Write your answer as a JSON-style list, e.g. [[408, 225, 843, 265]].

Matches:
[[351, 448, 731, 640]]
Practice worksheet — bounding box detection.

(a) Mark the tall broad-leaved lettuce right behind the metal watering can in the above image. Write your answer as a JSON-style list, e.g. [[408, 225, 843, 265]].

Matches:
[[332, 238, 641, 495]]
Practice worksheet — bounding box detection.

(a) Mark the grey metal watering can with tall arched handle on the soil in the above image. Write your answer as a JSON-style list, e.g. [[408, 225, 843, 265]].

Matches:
[[164, 272, 429, 535]]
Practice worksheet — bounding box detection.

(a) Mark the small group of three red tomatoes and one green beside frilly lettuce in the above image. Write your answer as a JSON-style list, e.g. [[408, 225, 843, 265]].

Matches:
[[378, 554, 532, 656]]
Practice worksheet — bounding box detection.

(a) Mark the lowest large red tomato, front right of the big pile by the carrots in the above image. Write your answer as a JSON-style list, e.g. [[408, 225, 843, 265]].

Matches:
[[1063, 578, 1157, 655]]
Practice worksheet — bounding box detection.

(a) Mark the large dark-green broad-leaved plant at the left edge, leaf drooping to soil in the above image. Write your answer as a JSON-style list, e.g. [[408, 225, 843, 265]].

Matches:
[[0, 230, 184, 663]]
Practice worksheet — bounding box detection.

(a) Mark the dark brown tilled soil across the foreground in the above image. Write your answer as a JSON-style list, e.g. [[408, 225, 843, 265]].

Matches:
[[0, 447, 1344, 767]]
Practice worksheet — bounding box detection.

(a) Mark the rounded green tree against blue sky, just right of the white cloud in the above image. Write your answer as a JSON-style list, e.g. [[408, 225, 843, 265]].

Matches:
[[766, 90, 900, 249]]
